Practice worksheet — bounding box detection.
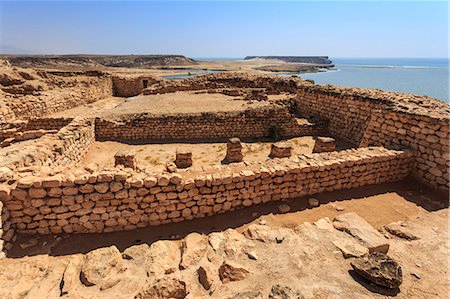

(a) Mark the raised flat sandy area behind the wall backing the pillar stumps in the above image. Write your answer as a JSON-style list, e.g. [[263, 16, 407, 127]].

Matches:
[[104, 91, 279, 115]]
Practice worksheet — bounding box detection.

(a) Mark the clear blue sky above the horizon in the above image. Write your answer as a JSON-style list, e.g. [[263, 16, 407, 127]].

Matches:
[[0, 0, 448, 57]]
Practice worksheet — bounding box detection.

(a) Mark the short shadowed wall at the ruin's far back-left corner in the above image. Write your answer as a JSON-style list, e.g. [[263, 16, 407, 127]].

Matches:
[[112, 76, 159, 97]]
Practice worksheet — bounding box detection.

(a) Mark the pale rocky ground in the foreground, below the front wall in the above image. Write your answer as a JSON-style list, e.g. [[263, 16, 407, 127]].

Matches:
[[0, 209, 449, 299]]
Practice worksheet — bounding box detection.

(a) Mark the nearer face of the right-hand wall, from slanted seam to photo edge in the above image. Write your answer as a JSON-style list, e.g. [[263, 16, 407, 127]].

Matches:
[[361, 110, 450, 191]]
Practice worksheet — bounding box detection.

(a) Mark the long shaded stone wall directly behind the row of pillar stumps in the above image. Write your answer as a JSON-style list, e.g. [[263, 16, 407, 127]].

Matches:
[[95, 105, 315, 140]]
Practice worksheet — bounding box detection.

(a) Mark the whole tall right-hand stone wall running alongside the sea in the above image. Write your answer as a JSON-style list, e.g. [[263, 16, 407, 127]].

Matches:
[[297, 86, 450, 191]]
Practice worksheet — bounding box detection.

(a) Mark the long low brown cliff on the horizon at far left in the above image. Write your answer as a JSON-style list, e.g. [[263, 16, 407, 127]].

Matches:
[[0, 55, 195, 68]]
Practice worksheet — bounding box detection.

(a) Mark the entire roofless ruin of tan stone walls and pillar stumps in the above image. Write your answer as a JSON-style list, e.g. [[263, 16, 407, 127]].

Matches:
[[0, 66, 450, 258]]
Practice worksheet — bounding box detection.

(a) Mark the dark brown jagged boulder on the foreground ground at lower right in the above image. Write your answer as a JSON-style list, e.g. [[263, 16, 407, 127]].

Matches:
[[351, 252, 403, 289]]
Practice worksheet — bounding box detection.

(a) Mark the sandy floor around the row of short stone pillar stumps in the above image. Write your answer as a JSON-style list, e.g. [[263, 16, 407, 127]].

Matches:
[[82, 136, 314, 170]]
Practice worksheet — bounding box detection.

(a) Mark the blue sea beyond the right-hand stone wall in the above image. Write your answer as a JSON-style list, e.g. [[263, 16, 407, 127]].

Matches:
[[298, 58, 450, 103]]
